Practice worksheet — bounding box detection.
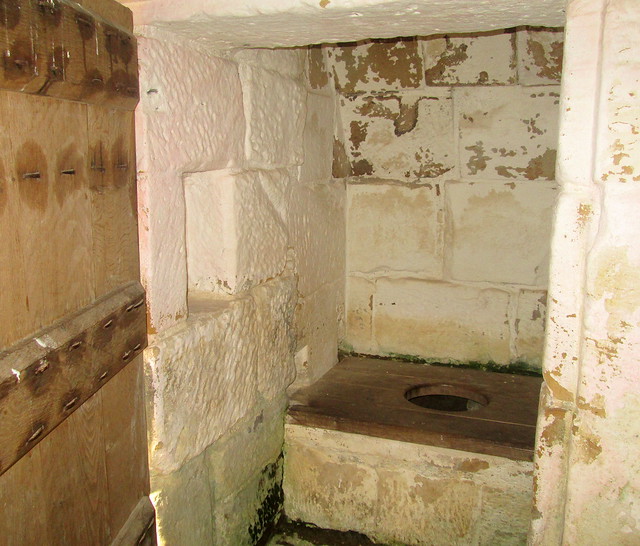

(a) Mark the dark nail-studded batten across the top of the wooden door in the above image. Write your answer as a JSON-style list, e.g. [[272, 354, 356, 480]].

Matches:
[[0, 0, 139, 110]]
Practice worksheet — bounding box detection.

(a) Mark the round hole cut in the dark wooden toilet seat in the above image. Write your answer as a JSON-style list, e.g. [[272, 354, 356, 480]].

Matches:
[[404, 383, 489, 411]]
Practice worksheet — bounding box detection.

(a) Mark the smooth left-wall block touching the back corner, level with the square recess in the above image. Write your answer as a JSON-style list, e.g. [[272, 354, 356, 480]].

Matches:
[[288, 183, 346, 296]]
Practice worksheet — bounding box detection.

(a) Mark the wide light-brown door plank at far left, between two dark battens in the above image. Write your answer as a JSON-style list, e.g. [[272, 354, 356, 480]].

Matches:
[[0, 91, 96, 347]]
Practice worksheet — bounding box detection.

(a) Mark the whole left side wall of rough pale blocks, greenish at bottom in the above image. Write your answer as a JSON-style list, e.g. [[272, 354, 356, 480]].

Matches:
[[137, 27, 345, 545]]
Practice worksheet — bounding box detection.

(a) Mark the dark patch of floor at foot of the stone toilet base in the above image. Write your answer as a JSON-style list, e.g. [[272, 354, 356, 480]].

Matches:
[[264, 518, 380, 546]]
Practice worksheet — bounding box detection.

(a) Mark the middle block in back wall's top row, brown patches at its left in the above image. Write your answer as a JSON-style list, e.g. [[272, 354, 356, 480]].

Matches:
[[420, 30, 517, 85]]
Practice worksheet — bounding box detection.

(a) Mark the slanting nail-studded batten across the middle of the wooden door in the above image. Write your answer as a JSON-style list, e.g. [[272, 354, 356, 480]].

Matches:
[[0, 283, 146, 473]]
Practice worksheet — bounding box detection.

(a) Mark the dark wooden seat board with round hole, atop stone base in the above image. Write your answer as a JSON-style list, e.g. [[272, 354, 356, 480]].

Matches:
[[287, 358, 540, 460]]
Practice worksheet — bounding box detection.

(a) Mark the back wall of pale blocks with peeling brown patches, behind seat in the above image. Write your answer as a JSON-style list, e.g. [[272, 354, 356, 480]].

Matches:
[[336, 28, 563, 369]]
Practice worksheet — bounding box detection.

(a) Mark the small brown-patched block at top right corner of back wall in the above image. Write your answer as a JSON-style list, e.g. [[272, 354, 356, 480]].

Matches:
[[517, 27, 564, 85]]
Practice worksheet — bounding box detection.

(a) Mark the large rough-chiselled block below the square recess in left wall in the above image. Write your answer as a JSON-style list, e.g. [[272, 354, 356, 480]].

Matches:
[[145, 297, 258, 474]]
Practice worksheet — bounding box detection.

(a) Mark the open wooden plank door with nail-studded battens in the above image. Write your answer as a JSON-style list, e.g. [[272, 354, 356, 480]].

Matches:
[[0, 0, 155, 546]]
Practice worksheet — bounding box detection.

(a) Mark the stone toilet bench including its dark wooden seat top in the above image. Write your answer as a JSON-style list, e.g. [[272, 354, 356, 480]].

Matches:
[[284, 358, 540, 545]]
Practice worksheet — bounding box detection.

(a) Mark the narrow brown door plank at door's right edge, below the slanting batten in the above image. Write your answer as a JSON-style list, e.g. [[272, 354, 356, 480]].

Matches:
[[101, 355, 149, 536]]
